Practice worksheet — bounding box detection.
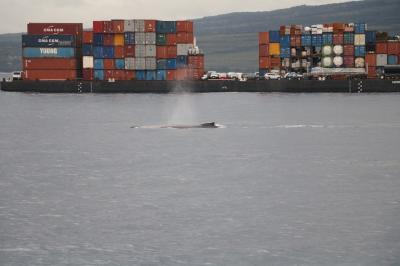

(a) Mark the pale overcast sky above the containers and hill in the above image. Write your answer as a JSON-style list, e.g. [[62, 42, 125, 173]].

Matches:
[[0, 0, 348, 33]]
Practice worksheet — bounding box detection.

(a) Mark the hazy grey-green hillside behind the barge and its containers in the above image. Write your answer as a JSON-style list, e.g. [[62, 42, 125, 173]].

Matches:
[[0, 0, 400, 72]]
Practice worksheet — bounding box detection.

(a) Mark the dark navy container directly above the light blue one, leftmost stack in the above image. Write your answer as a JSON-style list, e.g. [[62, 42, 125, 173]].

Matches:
[[22, 35, 76, 47]]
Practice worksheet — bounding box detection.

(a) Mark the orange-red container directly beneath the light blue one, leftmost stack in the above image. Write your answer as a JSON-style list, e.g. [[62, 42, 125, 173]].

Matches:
[[22, 58, 78, 70]]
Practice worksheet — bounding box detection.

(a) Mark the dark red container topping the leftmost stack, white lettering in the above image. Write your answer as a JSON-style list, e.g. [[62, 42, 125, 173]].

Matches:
[[28, 23, 83, 36]]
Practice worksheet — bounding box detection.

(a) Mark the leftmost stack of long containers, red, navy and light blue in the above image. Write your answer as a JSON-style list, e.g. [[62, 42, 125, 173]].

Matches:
[[22, 23, 83, 80]]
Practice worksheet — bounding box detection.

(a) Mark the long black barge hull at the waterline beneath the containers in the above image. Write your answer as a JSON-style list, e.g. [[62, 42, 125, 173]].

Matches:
[[1, 80, 400, 93]]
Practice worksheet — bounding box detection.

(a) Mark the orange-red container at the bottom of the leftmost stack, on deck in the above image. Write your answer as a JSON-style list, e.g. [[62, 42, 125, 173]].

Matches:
[[23, 69, 77, 80]]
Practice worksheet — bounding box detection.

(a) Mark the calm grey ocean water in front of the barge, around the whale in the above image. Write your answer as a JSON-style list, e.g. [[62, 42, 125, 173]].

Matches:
[[0, 92, 400, 266]]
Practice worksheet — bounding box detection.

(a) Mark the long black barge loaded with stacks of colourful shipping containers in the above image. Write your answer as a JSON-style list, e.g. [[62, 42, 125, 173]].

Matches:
[[1, 19, 400, 93]]
